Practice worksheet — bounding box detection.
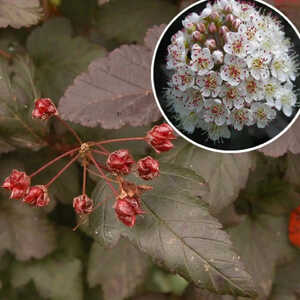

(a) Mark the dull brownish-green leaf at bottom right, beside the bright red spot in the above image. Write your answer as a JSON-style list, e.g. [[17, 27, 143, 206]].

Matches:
[[229, 215, 296, 299]]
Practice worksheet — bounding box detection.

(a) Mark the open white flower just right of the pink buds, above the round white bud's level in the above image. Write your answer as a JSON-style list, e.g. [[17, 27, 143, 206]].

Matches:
[[224, 32, 250, 58]]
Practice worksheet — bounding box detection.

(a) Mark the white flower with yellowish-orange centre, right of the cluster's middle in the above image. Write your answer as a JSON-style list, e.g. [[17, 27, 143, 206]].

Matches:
[[247, 50, 272, 80]]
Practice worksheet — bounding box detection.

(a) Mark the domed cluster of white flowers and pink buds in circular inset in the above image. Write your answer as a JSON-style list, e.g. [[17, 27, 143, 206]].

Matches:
[[165, 0, 298, 141]]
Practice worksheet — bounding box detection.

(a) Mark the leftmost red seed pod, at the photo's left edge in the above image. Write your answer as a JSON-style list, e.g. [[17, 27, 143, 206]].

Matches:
[[1, 169, 31, 199]]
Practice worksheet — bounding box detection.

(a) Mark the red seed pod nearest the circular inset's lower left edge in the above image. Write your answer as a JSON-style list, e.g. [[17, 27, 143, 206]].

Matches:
[[146, 123, 176, 153]]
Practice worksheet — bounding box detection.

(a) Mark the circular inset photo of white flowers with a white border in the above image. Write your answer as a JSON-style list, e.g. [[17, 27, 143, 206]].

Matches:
[[152, 0, 300, 153]]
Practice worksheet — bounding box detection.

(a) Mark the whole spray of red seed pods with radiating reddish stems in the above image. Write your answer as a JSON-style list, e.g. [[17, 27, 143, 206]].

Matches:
[[2, 98, 175, 227]]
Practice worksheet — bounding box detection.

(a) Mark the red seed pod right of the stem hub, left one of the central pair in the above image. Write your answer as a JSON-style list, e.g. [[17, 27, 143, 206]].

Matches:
[[106, 149, 134, 175]]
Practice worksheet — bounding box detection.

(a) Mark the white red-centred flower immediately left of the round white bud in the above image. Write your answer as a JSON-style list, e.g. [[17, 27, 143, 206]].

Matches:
[[191, 44, 214, 76]]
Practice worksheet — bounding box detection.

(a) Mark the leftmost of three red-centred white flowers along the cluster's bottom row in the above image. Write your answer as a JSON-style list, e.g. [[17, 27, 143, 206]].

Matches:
[[204, 99, 229, 126]]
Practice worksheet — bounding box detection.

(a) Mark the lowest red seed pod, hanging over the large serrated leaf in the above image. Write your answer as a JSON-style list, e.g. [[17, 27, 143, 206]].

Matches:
[[114, 196, 145, 227]]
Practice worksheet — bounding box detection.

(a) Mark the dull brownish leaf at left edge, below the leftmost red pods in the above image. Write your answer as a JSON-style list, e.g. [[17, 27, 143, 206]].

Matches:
[[0, 195, 56, 260]]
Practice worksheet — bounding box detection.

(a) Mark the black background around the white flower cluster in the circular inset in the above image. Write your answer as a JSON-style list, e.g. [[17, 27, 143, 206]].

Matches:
[[154, 1, 300, 150]]
